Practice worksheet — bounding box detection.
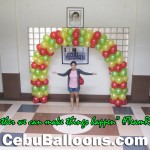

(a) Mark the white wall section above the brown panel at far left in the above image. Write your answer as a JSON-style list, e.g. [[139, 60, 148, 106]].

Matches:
[[0, 0, 19, 73]]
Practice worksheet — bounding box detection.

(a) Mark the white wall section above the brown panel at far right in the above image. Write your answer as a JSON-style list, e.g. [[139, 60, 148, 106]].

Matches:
[[133, 0, 150, 75]]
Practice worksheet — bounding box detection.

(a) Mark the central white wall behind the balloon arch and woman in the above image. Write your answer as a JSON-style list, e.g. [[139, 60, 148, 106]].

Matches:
[[16, 0, 136, 94]]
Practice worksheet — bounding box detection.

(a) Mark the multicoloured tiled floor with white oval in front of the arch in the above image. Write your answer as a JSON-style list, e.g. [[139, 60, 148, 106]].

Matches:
[[0, 101, 150, 150]]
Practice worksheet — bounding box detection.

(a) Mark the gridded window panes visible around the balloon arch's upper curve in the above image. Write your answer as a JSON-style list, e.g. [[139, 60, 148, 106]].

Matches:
[[28, 27, 129, 64]]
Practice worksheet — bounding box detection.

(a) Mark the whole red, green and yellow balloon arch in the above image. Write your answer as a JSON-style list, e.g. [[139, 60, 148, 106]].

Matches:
[[30, 28, 128, 106]]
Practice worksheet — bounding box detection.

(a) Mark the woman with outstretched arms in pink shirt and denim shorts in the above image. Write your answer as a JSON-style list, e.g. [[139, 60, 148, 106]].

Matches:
[[52, 61, 97, 109]]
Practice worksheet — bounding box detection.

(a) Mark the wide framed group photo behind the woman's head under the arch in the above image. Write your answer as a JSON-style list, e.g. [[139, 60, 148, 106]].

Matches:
[[61, 46, 89, 65]]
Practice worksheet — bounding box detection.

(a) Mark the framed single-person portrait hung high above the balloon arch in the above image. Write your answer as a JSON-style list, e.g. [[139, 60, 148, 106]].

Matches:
[[67, 7, 84, 28]]
